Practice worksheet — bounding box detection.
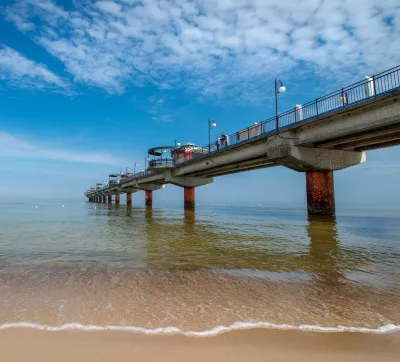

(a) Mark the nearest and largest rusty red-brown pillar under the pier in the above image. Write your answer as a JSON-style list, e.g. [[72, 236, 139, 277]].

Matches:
[[306, 171, 335, 215]]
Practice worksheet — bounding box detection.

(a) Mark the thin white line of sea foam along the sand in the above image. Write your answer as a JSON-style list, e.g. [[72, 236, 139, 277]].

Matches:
[[0, 322, 400, 337]]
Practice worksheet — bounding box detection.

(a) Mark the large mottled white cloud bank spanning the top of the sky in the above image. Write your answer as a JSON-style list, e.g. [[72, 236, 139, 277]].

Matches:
[[6, 0, 400, 101]]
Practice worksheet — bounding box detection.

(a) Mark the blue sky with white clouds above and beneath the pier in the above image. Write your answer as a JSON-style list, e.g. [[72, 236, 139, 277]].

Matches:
[[0, 0, 400, 206]]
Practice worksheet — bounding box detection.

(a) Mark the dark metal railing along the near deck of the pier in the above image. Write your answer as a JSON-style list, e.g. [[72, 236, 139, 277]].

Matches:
[[176, 66, 400, 165]]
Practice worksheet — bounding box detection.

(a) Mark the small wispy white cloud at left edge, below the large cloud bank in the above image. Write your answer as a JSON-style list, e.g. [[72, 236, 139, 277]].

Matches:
[[0, 47, 68, 88]]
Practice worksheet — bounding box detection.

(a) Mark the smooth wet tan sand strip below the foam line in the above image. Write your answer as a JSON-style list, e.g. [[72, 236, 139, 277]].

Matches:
[[0, 328, 400, 362]]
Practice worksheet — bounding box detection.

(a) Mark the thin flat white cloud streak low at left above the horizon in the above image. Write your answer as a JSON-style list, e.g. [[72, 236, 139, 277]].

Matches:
[[0, 131, 129, 166]]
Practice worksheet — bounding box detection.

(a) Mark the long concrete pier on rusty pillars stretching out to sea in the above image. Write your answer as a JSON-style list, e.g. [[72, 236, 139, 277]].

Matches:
[[85, 66, 400, 215]]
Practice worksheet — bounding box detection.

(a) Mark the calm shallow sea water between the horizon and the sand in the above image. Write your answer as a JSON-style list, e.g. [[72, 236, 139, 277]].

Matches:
[[0, 201, 400, 333]]
